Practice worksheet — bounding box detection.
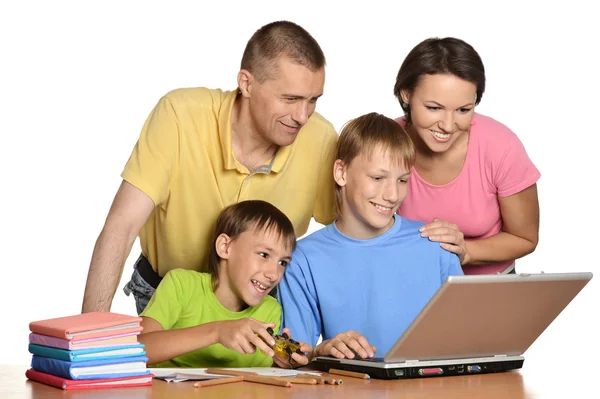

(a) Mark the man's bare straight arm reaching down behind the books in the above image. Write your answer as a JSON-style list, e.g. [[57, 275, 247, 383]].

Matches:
[[82, 180, 154, 313]]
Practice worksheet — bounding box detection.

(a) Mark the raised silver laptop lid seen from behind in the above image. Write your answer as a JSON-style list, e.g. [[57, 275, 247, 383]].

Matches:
[[384, 273, 592, 362]]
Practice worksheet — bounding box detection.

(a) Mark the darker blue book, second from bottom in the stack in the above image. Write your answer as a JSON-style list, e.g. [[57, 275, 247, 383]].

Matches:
[[31, 355, 150, 380]]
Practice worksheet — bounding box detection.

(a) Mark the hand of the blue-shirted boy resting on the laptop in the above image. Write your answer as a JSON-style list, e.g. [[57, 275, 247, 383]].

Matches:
[[314, 330, 377, 359]]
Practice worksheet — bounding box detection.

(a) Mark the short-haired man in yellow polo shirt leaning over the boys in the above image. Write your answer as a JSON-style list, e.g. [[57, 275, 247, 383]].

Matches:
[[82, 21, 337, 313]]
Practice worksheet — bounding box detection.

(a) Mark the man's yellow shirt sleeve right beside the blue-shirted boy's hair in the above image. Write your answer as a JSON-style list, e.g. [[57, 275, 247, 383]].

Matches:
[[313, 128, 338, 225]]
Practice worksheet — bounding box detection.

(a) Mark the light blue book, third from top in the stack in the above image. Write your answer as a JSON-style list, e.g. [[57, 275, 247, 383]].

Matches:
[[29, 344, 146, 362]]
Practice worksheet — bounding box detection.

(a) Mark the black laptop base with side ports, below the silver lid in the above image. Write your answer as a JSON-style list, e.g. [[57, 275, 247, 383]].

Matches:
[[310, 357, 524, 380]]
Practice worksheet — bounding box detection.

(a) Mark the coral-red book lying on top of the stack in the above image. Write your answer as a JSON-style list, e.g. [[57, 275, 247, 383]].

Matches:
[[29, 312, 142, 341]]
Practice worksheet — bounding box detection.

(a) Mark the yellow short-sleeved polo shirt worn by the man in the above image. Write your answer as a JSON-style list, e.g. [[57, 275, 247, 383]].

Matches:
[[121, 88, 338, 276]]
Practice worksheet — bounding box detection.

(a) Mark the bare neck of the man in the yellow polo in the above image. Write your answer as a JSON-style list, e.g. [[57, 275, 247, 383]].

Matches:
[[231, 95, 279, 171]]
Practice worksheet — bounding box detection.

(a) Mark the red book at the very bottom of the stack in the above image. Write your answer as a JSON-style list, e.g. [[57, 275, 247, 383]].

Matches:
[[25, 369, 154, 390]]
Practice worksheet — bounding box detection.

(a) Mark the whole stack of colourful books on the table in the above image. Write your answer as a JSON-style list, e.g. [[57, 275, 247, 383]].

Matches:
[[25, 312, 153, 389]]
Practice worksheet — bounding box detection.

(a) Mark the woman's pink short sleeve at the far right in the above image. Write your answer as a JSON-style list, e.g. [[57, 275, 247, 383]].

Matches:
[[495, 127, 541, 197]]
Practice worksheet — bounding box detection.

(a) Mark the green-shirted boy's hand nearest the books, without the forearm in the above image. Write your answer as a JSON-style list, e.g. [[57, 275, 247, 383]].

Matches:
[[217, 317, 275, 357]]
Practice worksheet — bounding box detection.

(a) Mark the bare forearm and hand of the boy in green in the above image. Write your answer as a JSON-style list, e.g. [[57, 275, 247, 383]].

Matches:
[[139, 317, 275, 365]]
